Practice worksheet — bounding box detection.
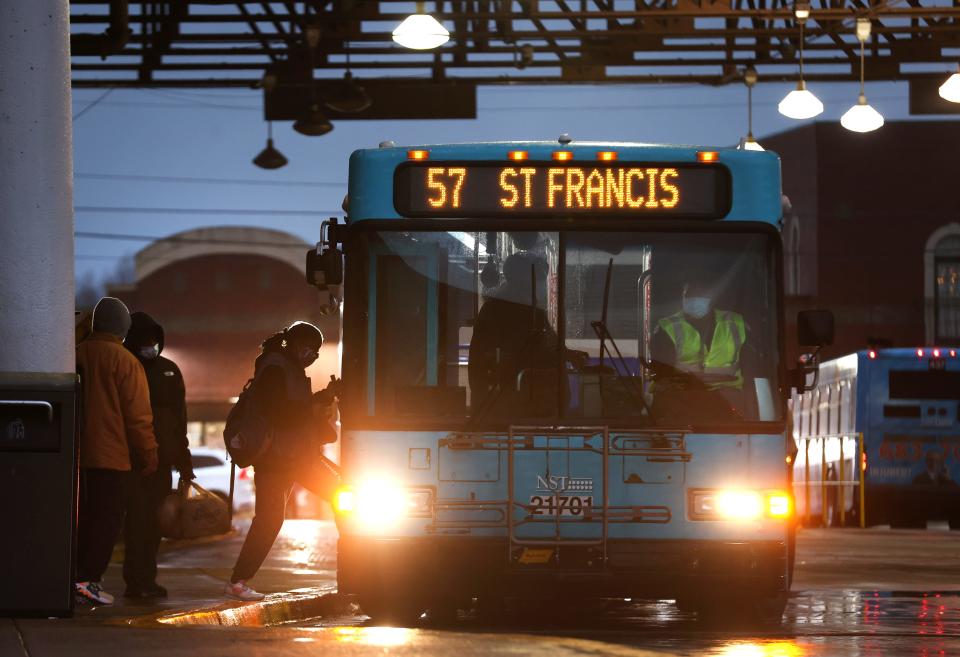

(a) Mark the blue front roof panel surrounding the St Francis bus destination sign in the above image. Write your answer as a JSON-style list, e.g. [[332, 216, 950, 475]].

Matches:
[[348, 141, 782, 227]]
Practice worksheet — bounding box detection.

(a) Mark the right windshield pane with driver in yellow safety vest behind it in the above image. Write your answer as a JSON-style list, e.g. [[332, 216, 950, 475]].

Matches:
[[563, 232, 782, 424]]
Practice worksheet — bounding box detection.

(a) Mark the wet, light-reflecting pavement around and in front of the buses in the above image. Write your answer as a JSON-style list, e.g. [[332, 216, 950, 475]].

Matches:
[[0, 520, 960, 657]]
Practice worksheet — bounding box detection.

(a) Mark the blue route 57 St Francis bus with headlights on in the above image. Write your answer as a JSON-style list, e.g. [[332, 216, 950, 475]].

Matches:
[[307, 138, 832, 623]]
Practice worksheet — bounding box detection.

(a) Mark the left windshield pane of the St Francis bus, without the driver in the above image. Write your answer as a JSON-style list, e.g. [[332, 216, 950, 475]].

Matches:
[[358, 231, 558, 420]]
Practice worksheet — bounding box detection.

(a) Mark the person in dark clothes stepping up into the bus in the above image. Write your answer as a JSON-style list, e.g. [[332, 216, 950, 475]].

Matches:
[[224, 322, 340, 600]]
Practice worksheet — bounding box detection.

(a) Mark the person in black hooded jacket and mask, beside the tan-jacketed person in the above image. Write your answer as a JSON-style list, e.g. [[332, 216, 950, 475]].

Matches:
[[123, 312, 194, 598]]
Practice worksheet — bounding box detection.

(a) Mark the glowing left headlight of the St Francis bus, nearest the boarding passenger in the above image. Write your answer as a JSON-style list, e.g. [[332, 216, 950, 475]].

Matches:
[[334, 480, 433, 527]]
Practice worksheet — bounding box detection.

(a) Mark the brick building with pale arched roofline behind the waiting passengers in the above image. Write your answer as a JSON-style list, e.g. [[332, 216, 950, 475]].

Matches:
[[110, 227, 339, 447]]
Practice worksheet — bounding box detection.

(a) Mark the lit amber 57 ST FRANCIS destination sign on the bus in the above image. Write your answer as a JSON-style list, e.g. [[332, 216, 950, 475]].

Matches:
[[394, 162, 730, 219]]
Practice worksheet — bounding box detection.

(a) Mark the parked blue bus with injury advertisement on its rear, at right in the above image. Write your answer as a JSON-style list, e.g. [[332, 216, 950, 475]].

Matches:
[[792, 347, 960, 529]]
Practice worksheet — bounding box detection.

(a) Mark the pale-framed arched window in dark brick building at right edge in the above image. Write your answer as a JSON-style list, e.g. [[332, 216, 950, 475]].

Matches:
[[924, 223, 960, 345]]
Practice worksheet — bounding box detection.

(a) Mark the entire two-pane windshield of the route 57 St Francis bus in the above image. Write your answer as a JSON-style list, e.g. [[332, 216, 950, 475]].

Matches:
[[347, 228, 783, 430]]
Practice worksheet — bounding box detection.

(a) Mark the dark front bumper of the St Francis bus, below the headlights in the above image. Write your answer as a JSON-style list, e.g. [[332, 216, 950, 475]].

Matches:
[[337, 536, 788, 599]]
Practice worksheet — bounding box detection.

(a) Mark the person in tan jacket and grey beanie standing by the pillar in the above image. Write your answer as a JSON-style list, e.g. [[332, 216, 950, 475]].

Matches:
[[75, 297, 157, 604]]
